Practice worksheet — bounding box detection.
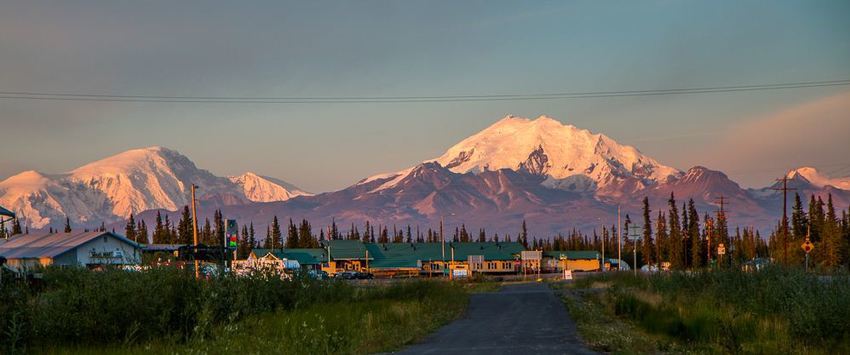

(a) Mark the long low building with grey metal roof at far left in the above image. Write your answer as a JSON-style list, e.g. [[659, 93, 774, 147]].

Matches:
[[0, 232, 141, 271]]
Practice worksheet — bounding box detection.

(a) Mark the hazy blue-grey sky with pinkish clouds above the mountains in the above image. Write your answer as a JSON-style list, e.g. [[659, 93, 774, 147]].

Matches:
[[0, 0, 850, 192]]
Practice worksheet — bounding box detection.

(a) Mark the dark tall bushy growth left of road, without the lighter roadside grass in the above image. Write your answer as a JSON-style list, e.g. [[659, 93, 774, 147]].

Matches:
[[0, 268, 360, 353]]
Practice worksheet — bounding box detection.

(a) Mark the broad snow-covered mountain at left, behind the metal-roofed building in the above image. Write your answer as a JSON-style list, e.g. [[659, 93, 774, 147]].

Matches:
[[0, 147, 304, 228]]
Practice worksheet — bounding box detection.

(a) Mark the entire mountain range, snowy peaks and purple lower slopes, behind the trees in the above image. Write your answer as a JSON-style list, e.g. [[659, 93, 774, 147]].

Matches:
[[0, 116, 850, 236]]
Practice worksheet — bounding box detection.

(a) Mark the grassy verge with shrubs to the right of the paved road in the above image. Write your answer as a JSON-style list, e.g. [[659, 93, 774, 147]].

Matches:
[[552, 268, 850, 354]]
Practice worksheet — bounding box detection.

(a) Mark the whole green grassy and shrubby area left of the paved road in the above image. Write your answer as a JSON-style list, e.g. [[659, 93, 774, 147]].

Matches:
[[0, 270, 470, 354]]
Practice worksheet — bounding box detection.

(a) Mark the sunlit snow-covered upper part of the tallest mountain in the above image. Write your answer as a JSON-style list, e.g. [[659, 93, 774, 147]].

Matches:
[[361, 116, 682, 197]]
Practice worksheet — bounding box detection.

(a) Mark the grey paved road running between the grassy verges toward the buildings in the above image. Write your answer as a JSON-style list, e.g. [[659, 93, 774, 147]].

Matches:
[[394, 283, 592, 355]]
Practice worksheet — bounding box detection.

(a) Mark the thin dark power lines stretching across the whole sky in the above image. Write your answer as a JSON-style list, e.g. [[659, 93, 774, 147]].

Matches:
[[0, 79, 850, 104]]
